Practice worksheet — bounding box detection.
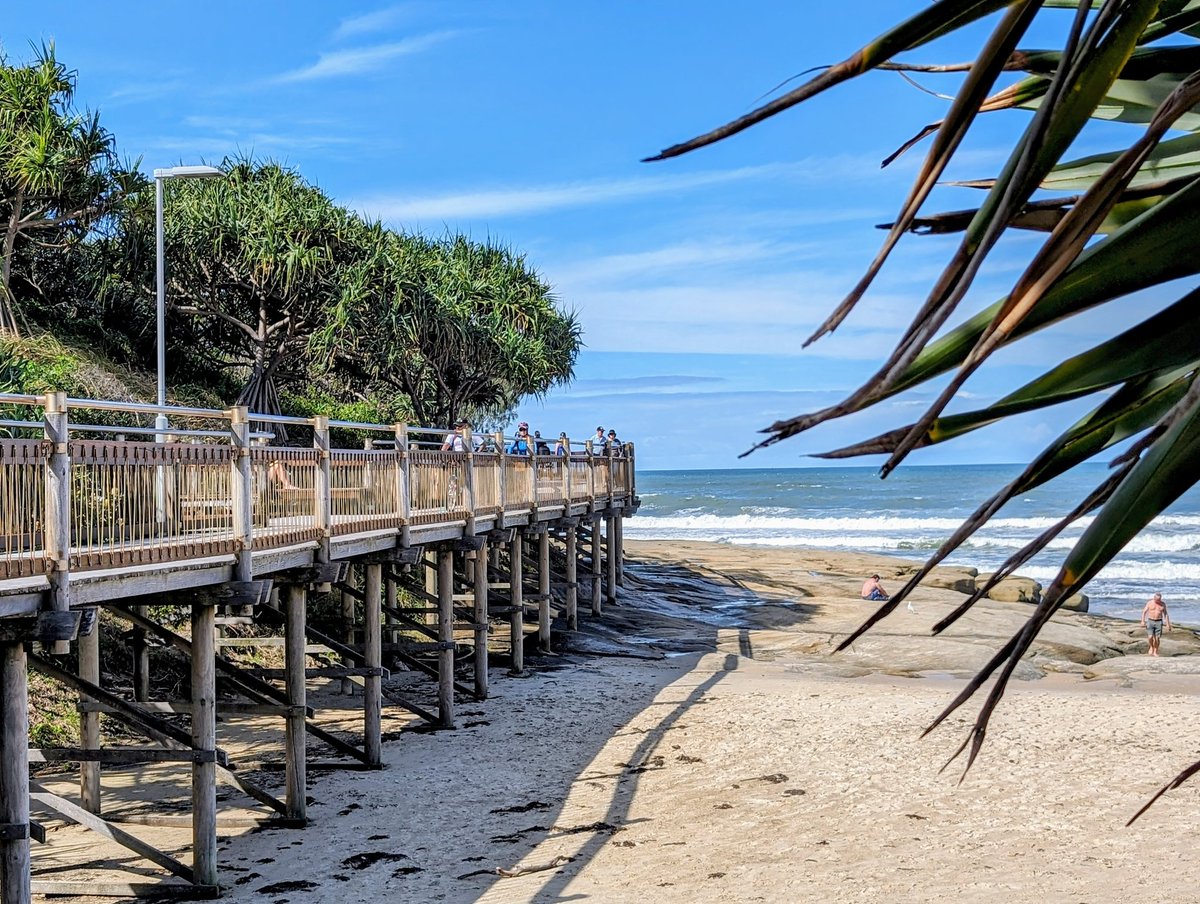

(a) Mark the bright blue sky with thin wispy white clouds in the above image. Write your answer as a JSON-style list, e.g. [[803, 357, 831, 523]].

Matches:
[[0, 7, 1174, 468]]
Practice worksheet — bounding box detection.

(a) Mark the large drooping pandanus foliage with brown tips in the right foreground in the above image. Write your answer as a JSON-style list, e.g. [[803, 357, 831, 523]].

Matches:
[[652, 0, 1200, 818]]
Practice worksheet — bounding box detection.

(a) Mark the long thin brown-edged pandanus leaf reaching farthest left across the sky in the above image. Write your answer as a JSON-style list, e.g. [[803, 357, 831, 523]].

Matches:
[[646, 0, 1013, 162]]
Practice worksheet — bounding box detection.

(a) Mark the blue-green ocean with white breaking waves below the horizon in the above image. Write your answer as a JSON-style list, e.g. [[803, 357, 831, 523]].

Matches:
[[625, 463, 1200, 625]]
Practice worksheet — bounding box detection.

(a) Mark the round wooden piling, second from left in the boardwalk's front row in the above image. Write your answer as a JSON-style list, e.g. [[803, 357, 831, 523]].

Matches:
[[192, 603, 217, 887]]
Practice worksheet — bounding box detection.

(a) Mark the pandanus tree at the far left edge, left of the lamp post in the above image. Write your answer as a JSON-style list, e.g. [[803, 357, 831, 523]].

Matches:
[[0, 46, 136, 334]]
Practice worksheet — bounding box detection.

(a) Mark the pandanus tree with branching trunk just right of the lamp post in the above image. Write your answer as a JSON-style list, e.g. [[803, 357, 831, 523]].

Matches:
[[164, 160, 368, 436]]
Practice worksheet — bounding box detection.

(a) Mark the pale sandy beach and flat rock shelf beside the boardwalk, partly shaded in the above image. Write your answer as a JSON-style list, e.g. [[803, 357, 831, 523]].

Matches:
[[37, 543, 1200, 904]]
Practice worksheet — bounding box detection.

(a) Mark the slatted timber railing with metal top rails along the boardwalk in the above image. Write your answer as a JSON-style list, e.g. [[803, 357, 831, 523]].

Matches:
[[0, 393, 635, 585]]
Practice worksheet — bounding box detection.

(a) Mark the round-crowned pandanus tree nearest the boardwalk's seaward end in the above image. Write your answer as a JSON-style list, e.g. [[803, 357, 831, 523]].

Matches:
[[318, 231, 582, 424]]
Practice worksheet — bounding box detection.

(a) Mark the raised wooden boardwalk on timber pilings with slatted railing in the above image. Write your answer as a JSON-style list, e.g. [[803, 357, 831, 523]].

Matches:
[[0, 393, 637, 904]]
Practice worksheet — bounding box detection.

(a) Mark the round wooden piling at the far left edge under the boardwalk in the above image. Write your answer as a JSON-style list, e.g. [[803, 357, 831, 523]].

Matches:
[[0, 642, 31, 904]]
